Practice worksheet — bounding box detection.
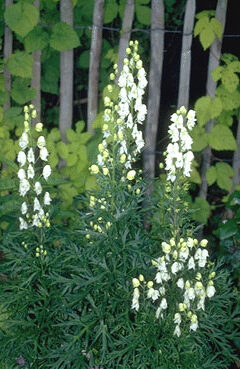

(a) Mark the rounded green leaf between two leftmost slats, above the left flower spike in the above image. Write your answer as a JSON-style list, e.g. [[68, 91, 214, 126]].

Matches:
[[7, 51, 33, 78]]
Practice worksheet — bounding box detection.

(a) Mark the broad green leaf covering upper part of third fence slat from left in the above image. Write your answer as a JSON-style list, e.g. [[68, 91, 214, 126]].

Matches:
[[50, 22, 80, 51]]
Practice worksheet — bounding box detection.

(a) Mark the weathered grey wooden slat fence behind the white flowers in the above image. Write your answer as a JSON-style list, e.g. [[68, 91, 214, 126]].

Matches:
[[4, 0, 236, 203]]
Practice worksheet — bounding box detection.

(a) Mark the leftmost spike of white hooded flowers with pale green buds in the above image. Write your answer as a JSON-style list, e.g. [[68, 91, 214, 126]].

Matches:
[[17, 105, 52, 230]]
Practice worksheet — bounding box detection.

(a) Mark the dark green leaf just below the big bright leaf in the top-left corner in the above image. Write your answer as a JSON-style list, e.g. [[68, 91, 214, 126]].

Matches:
[[24, 26, 49, 53]]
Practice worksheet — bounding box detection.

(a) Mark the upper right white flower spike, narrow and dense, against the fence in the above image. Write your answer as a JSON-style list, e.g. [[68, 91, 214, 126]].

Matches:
[[165, 106, 196, 182]]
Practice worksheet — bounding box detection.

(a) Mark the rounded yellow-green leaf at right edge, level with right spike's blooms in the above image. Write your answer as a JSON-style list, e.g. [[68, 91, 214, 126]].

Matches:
[[208, 124, 237, 151]]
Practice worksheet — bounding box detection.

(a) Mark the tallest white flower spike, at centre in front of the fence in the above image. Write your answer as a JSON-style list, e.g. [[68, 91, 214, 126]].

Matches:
[[90, 41, 147, 181]]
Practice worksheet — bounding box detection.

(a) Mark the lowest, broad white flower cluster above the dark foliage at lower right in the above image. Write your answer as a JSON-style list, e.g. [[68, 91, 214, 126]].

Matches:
[[132, 237, 216, 337]]
